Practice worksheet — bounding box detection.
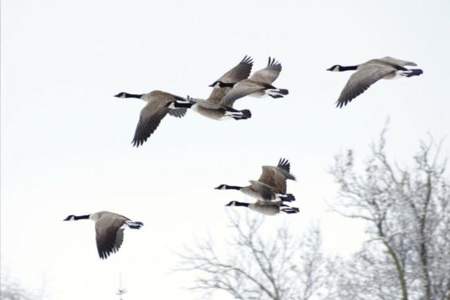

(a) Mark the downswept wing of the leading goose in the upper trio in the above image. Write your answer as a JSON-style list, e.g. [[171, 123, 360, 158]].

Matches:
[[132, 92, 180, 147]]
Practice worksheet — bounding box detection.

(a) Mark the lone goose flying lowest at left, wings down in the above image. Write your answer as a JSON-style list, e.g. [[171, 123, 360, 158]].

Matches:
[[64, 211, 144, 259]]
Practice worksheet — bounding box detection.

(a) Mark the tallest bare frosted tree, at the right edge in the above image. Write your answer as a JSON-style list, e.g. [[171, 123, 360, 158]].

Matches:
[[331, 129, 450, 300]]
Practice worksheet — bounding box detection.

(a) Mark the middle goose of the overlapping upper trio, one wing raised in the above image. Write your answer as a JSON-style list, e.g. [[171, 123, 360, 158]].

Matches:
[[183, 56, 253, 120]]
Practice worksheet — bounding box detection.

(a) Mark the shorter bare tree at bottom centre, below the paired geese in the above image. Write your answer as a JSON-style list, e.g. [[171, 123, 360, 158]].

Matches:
[[180, 215, 329, 300]]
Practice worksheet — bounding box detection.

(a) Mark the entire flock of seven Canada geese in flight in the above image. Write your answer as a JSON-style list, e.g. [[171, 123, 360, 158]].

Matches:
[[64, 56, 423, 259]]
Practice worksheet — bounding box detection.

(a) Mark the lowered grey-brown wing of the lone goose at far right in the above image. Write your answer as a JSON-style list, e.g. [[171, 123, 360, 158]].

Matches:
[[336, 63, 396, 108]]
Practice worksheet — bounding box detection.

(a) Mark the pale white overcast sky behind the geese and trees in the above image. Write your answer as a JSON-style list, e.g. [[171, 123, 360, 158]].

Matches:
[[1, 0, 450, 300]]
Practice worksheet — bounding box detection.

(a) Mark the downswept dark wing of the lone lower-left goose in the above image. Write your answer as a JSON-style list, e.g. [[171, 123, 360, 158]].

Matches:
[[95, 214, 128, 259]]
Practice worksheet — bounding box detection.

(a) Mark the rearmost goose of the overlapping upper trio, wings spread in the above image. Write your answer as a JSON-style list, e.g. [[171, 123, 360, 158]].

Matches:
[[221, 57, 289, 106]]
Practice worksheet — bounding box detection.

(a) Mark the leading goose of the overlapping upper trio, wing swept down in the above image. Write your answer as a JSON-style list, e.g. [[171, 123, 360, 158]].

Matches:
[[114, 90, 191, 147]]
